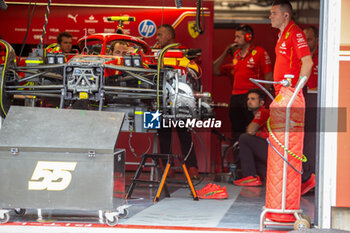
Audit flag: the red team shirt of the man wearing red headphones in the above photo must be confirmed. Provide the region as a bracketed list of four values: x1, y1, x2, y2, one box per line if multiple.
[232, 44, 272, 95]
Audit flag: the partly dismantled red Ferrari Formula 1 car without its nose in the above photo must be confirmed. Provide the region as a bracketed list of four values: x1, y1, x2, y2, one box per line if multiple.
[0, 33, 213, 132]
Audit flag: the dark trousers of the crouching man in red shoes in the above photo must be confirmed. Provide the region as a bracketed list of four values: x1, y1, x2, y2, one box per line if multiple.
[239, 133, 268, 177]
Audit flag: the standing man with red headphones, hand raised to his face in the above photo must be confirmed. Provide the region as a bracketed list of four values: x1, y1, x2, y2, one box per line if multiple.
[213, 25, 272, 141]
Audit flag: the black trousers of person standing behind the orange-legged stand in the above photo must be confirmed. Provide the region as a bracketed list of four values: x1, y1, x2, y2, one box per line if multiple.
[158, 127, 198, 168]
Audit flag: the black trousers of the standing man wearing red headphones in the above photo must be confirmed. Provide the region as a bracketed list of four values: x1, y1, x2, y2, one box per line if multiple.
[229, 94, 254, 142]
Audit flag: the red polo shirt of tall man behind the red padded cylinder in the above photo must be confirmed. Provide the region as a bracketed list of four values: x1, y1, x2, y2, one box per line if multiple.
[273, 20, 310, 93]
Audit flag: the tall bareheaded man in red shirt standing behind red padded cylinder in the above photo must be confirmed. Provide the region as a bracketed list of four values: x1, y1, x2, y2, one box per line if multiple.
[269, 0, 313, 94]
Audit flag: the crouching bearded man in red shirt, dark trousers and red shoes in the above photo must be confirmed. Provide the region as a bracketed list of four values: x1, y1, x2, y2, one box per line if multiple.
[233, 89, 270, 186]
